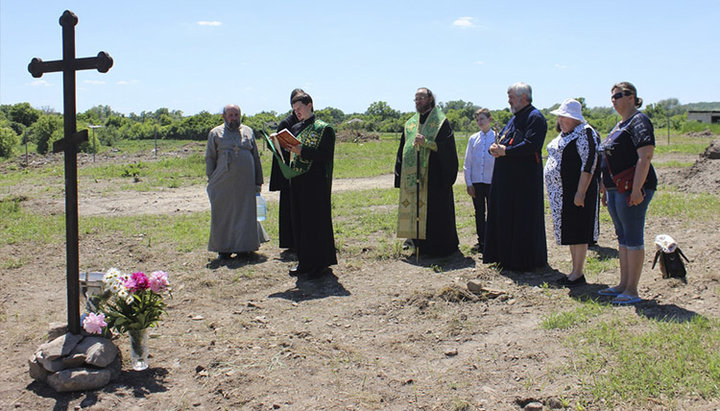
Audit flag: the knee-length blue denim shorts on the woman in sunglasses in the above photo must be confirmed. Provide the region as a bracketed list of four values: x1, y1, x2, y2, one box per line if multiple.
[607, 190, 655, 250]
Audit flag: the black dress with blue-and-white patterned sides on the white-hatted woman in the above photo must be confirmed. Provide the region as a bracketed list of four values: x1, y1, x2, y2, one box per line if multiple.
[544, 124, 600, 245]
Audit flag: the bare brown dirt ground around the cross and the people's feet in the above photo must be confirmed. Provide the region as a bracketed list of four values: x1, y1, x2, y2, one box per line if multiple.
[0, 140, 720, 410]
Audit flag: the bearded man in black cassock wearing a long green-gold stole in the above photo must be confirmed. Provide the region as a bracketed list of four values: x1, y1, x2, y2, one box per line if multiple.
[395, 88, 459, 257]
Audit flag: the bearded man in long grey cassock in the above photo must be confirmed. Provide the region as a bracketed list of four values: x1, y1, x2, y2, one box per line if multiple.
[205, 104, 269, 259]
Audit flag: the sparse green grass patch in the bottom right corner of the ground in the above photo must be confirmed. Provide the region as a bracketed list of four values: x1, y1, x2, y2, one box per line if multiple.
[572, 316, 720, 406]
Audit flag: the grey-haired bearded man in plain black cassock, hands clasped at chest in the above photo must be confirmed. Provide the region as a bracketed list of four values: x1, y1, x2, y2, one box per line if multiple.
[483, 83, 547, 271]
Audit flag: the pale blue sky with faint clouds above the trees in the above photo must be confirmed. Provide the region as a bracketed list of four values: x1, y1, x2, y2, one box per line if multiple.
[0, 0, 720, 115]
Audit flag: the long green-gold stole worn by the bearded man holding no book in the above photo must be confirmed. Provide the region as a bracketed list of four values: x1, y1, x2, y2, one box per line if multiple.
[397, 107, 445, 240]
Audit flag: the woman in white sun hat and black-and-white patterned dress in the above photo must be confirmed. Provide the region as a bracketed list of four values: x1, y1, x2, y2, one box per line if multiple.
[544, 99, 600, 287]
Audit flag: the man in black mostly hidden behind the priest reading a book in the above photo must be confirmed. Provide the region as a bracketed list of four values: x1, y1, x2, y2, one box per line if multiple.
[269, 88, 305, 251]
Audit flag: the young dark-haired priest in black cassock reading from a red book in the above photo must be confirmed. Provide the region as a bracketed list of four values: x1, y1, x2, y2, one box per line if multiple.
[289, 93, 337, 278]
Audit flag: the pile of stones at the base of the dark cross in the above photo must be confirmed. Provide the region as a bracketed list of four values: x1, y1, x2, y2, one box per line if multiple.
[28, 327, 122, 392]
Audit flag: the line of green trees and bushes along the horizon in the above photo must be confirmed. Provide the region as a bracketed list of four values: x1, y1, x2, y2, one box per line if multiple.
[0, 97, 720, 158]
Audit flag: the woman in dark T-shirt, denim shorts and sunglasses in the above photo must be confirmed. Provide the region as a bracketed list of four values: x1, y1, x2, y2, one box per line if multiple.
[598, 82, 657, 305]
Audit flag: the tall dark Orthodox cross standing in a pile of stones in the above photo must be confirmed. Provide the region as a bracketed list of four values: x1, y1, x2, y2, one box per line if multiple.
[28, 10, 113, 334]
